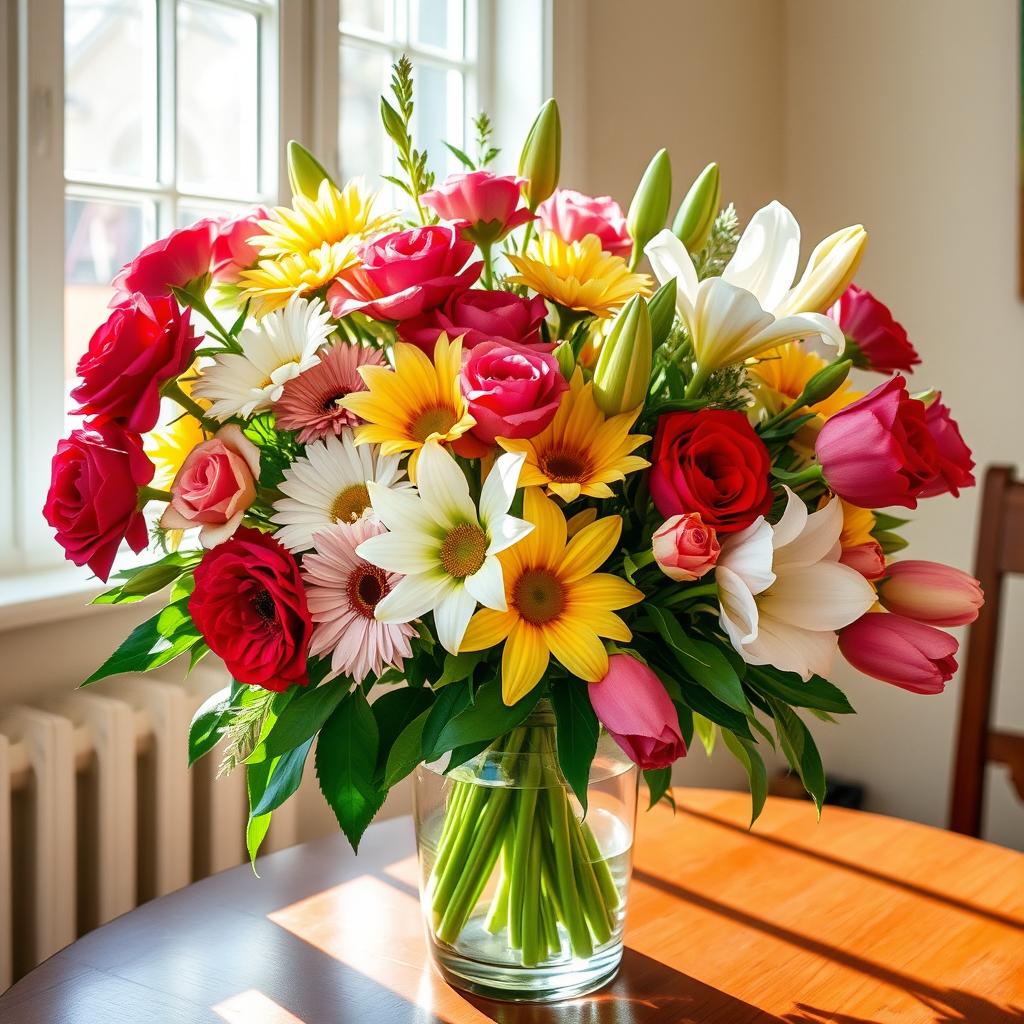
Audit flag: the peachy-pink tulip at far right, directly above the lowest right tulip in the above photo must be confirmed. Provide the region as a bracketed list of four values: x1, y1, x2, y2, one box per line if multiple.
[879, 559, 985, 626]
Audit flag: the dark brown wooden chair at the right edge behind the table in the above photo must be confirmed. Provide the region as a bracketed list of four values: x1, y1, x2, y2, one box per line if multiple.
[949, 466, 1024, 836]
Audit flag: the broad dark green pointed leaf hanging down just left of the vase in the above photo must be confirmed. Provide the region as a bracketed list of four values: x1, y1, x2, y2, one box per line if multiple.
[316, 689, 386, 852]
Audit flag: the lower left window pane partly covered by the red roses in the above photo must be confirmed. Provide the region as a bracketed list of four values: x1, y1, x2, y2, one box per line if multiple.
[65, 196, 156, 393]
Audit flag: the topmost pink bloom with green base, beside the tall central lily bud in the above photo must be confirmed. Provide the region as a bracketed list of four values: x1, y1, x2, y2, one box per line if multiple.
[423, 171, 535, 246]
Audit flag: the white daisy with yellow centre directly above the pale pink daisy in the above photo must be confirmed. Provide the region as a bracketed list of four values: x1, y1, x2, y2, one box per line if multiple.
[271, 427, 411, 551]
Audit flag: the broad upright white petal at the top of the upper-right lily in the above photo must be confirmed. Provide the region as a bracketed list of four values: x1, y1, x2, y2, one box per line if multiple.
[722, 200, 800, 310]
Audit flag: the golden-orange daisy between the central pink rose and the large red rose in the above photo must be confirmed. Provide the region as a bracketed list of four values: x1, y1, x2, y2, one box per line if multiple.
[498, 370, 650, 502]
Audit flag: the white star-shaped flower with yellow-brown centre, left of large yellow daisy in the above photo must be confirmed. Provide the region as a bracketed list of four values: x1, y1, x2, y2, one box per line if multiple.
[356, 441, 534, 654]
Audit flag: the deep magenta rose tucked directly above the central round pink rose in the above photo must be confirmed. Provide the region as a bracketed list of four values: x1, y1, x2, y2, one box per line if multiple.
[398, 288, 553, 355]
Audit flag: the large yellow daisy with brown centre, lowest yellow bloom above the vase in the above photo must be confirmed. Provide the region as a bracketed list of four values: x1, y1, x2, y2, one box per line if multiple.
[460, 487, 643, 705]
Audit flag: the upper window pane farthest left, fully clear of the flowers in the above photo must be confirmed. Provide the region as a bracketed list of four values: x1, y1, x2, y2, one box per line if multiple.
[65, 0, 157, 180]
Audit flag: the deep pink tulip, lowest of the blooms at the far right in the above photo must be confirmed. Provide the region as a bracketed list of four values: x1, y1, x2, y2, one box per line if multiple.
[839, 611, 959, 693]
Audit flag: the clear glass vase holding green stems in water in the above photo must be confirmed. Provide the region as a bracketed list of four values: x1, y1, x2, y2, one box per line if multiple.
[414, 701, 638, 1002]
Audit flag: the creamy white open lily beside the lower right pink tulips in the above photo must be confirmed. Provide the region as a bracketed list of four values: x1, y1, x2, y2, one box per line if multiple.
[715, 487, 876, 680]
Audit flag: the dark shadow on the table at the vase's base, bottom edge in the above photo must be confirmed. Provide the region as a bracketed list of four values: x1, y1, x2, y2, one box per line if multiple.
[465, 948, 779, 1024]
